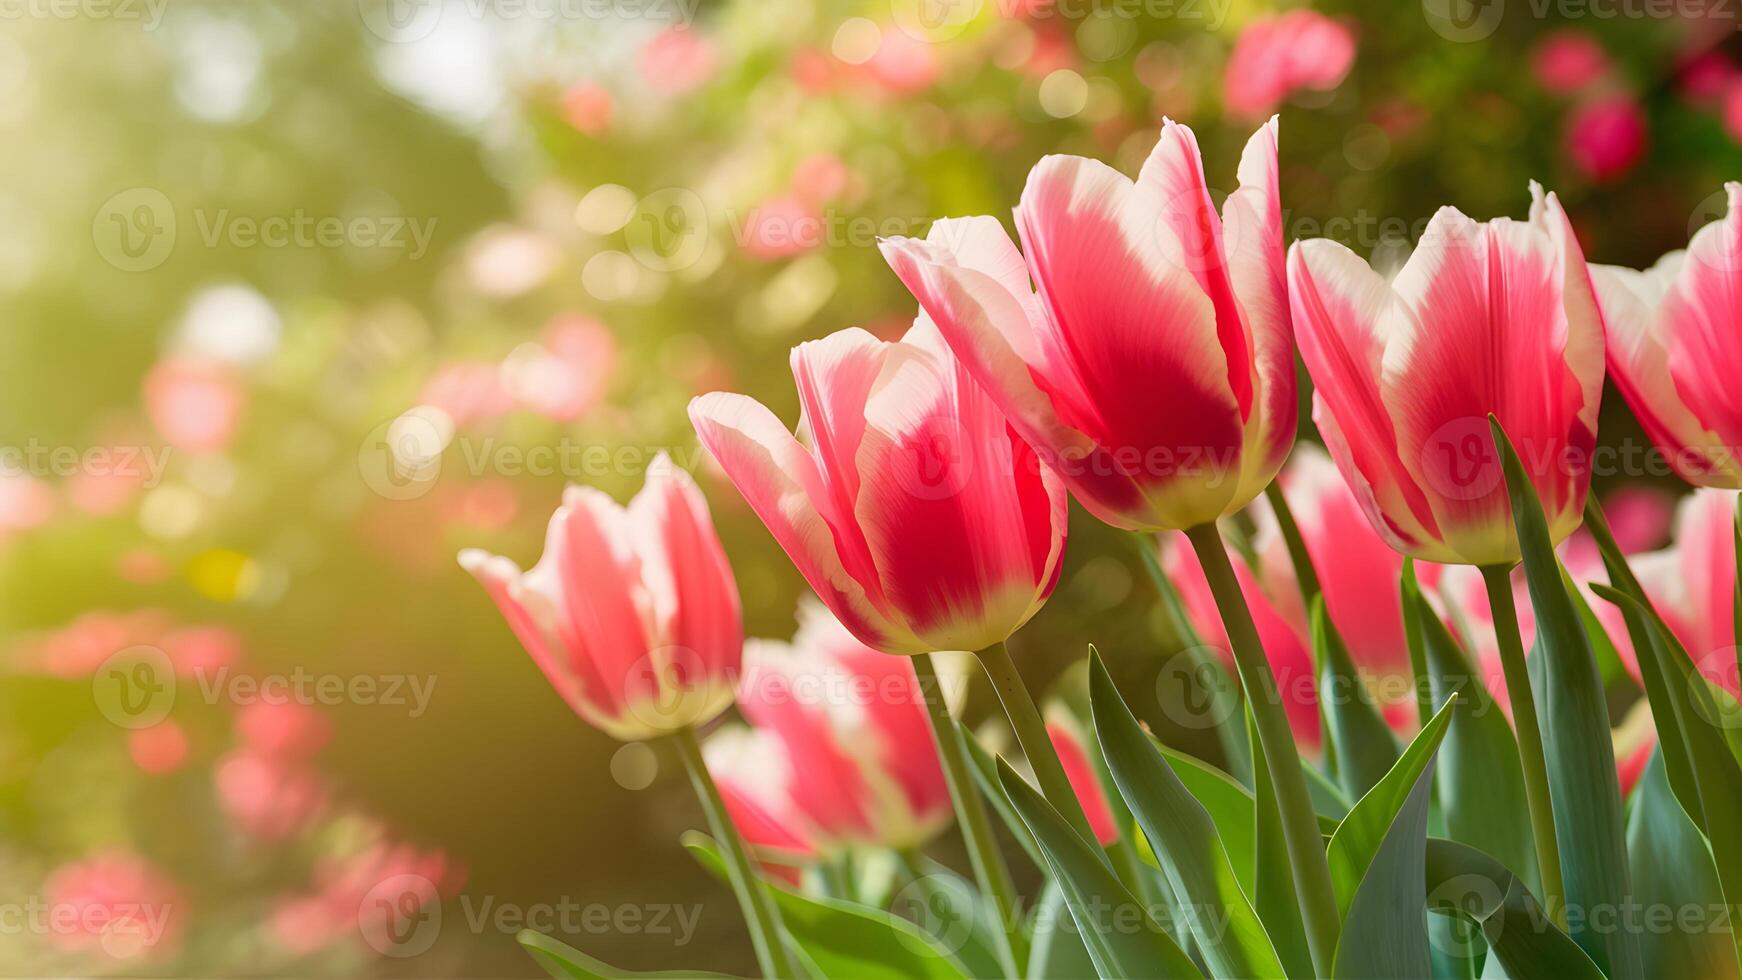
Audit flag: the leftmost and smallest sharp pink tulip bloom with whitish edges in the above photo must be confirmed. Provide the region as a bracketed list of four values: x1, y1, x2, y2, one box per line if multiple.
[460, 454, 744, 740]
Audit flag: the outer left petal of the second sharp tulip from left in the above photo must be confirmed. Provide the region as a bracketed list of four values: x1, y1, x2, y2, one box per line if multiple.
[690, 392, 913, 649]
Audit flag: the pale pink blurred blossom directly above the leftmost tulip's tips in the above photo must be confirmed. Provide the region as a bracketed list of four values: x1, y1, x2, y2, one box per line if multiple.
[502, 313, 617, 421]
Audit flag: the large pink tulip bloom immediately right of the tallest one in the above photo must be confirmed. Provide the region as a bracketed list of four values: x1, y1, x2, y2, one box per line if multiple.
[1289, 185, 1603, 564]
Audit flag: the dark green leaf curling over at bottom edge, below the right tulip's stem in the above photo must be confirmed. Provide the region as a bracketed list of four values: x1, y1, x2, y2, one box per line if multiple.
[1427, 837, 1595, 980]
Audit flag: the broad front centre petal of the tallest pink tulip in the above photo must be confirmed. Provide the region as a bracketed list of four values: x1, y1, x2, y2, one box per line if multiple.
[1017, 157, 1242, 527]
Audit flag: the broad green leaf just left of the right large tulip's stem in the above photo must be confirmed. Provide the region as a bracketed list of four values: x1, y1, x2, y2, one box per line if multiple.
[1409, 594, 1536, 888]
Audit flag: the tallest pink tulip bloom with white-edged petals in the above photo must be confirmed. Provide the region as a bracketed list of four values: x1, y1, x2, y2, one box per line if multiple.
[883, 120, 1294, 529]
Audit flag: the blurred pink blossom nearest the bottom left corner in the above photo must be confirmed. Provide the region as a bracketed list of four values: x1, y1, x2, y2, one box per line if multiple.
[42, 849, 186, 959]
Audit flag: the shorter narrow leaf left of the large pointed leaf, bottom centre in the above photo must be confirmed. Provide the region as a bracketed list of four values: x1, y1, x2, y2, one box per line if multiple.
[998, 759, 1202, 978]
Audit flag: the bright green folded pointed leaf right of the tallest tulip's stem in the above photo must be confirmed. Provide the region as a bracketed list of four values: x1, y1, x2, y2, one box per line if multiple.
[1326, 698, 1456, 980]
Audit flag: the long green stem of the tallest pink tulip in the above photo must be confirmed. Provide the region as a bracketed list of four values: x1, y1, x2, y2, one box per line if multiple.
[1186, 522, 1341, 977]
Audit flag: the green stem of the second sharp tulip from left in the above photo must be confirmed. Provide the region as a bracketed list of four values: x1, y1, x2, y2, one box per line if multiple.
[902, 653, 1028, 977]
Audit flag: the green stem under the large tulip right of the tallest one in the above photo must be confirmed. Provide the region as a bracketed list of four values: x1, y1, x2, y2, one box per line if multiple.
[1481, 564, 1566, 928]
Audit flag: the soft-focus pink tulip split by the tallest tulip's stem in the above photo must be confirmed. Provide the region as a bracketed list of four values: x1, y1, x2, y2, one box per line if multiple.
[1162, 534, 1319, 752]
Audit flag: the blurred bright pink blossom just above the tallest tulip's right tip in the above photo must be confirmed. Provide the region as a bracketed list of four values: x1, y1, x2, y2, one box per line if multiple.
[1223, 10, 1355, 118]
